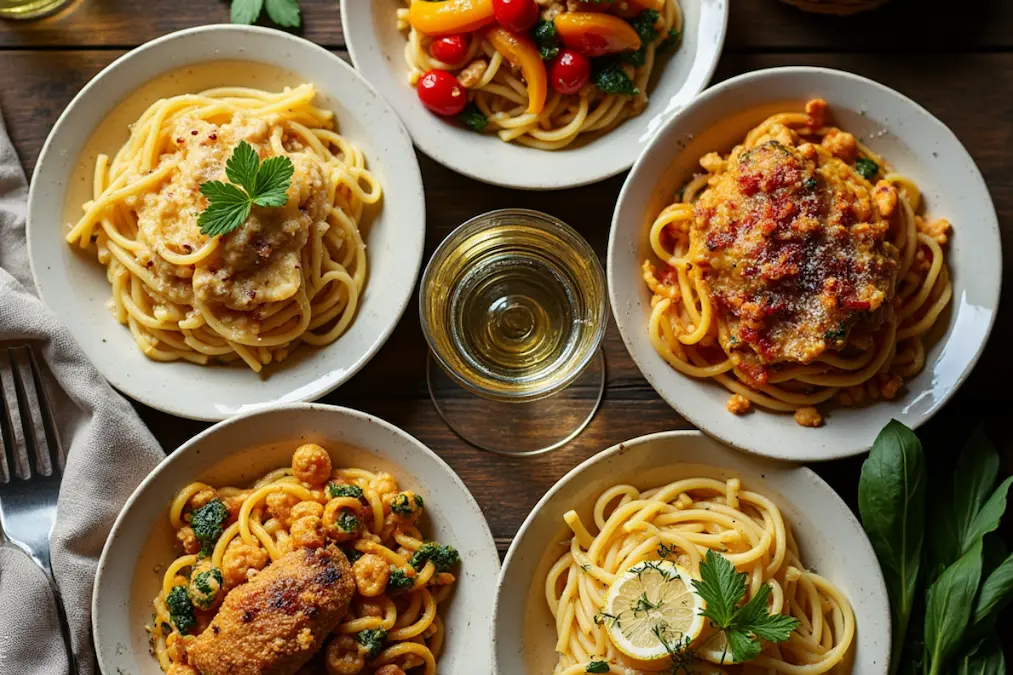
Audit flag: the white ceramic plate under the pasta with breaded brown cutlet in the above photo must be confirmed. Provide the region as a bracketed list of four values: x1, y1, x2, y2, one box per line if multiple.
[92, 403, 499, 675]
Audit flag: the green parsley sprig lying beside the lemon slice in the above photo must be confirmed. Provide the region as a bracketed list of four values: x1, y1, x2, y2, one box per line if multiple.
[693, 550, 799, 663]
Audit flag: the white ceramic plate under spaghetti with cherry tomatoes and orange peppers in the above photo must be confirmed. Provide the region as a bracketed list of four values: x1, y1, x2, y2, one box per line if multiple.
[341, 0, 728, 190]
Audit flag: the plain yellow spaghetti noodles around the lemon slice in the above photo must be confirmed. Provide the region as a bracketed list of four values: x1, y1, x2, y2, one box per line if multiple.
[545, 477, 855, 675]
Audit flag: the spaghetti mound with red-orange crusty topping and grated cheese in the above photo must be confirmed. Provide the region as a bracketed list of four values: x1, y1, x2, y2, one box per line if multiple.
[643, 99, 952, 426]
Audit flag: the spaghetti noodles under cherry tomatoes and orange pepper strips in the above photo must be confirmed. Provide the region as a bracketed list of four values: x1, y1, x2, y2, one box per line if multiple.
[397, 0, 683, 150]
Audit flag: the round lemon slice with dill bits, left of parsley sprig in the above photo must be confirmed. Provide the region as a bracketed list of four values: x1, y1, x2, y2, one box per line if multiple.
[602, 560, 704, 667]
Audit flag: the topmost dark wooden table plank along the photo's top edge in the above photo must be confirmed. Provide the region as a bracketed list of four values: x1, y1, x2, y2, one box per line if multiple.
[0, 0, 1013, 52]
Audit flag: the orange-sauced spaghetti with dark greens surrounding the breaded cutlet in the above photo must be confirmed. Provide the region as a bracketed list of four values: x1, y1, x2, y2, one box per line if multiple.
[147, 444, 459, 675]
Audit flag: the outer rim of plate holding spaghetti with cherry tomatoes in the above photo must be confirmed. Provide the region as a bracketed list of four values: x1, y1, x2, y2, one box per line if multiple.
[339, 0, 731, 192]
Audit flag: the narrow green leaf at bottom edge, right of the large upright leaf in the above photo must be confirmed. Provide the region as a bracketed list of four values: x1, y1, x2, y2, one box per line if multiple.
[925, 539, 982, 675]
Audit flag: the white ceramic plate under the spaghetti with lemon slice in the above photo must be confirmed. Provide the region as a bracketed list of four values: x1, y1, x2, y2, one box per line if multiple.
[492, 431, 890, 675]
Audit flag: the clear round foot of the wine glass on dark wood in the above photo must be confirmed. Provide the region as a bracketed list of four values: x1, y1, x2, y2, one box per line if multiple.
[425, 349, 605, 456]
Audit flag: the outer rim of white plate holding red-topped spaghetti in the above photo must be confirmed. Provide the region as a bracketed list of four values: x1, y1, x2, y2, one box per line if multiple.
[606, 66, 1003, 462]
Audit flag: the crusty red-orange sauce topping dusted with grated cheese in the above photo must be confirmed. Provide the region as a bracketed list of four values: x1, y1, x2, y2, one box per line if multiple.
[689, 138, 899, 385]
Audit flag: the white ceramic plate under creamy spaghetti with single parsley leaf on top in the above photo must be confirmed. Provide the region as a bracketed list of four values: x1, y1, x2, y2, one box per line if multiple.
[28, 25, 425, 420]
